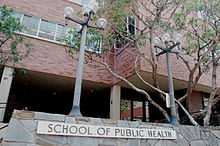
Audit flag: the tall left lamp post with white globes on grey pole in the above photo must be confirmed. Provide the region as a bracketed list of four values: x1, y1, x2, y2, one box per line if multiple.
[64, 3, 107, 117]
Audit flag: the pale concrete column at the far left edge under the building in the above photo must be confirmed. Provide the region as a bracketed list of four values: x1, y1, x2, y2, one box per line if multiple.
[0, 67, 14, 122]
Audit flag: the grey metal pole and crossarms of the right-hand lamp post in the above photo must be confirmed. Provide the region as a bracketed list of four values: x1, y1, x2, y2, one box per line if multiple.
[155, 42, 180, 124]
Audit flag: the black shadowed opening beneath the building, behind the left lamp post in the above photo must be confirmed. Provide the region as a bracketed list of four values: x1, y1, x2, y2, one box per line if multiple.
[4, 70, 110, 122]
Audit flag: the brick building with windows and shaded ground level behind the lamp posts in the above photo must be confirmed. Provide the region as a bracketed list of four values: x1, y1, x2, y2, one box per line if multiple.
[0, 0, 219, 124]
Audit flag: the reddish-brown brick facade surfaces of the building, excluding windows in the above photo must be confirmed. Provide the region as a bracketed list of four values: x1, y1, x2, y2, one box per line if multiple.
[0, 0, 217, 89]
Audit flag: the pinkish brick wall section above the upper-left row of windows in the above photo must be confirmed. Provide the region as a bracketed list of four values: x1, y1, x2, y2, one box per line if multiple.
[0, 0, 80, 23]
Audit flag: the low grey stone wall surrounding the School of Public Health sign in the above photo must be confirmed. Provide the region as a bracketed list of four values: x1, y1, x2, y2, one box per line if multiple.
[2, 111, 220, 146]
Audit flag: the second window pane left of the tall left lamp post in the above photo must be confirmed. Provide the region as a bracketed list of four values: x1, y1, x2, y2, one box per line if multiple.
[38, 19, 56, 40]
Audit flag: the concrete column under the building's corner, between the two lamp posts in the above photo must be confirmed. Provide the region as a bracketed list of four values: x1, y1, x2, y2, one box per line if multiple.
[110, 85, 121, 120]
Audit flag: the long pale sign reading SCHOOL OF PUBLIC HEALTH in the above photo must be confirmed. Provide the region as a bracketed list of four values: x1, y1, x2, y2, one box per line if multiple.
[37, 121, 176, 139]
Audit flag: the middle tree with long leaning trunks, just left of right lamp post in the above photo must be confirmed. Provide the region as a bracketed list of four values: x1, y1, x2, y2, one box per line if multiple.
[96, 0, 197, 125]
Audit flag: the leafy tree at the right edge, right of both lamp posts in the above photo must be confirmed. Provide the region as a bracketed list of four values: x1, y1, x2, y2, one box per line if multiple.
[172, 0, 220, 126]
